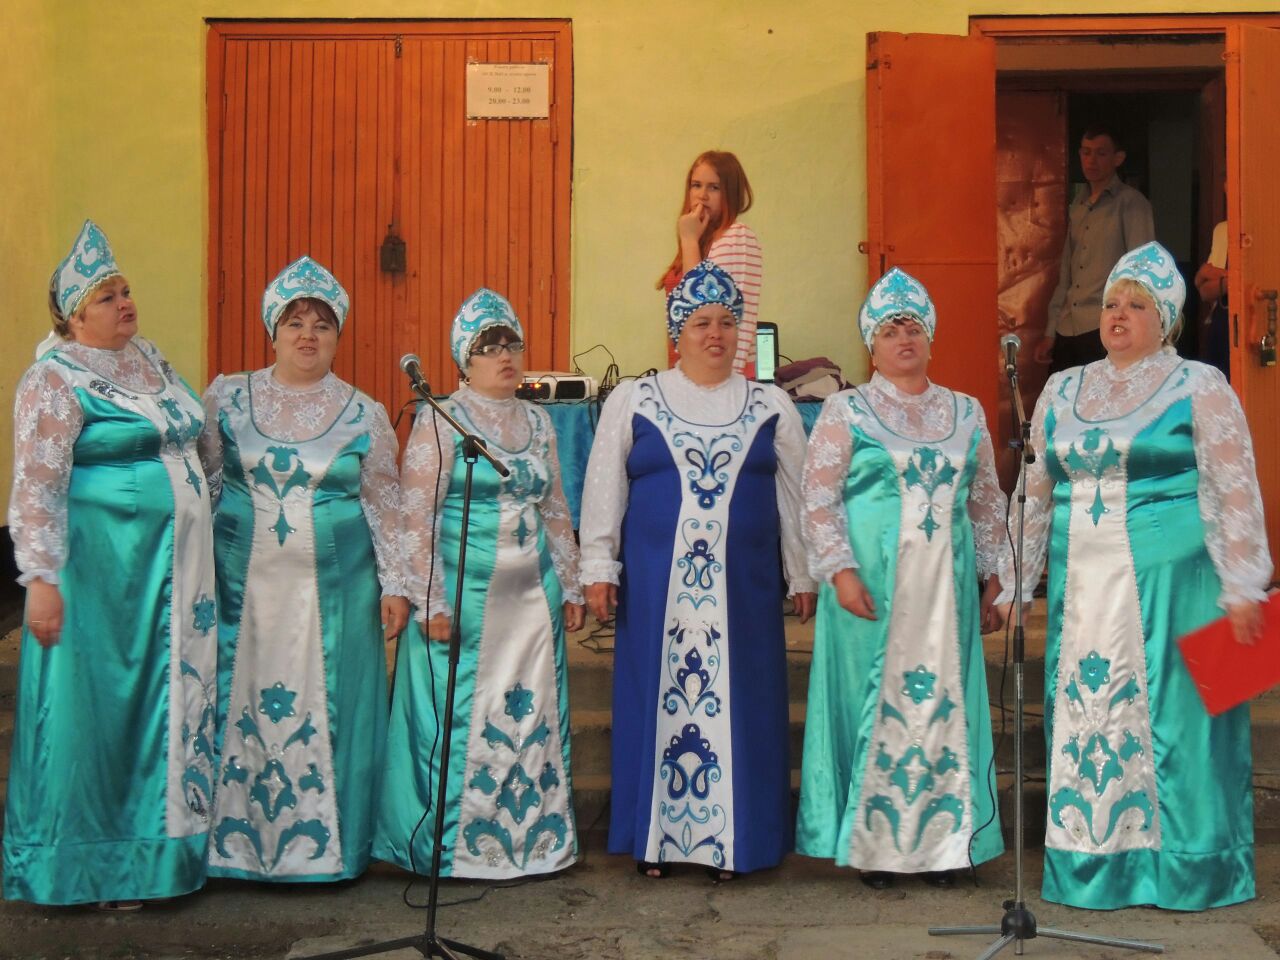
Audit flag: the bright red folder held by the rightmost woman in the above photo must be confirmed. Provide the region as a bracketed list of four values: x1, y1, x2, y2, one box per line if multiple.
[1178, 594, 1280, 717]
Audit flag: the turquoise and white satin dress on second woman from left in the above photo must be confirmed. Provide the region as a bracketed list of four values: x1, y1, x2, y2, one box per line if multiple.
[209, 374, 387, 882]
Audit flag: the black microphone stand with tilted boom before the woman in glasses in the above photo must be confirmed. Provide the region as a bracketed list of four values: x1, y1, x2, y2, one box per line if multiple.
[303, 374, 511, 960]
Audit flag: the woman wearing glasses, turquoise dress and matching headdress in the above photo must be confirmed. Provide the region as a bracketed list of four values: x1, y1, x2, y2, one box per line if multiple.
[374, 288, 585, 879]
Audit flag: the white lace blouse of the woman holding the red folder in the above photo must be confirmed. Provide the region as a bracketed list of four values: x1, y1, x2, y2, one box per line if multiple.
[1023, 348, 1271, 607]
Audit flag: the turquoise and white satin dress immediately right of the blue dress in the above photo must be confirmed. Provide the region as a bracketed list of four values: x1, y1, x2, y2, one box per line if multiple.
[796, 389, 1004, 873]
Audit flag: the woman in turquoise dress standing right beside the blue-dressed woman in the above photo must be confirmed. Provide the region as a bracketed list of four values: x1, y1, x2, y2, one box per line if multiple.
[796, 269, 1012, 890]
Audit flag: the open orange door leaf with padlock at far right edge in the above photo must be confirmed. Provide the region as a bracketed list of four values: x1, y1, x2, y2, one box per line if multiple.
[1226, 24, 1280, 570]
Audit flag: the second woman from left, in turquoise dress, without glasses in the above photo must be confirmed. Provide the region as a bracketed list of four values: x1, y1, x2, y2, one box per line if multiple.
[200, 256, 408, 882]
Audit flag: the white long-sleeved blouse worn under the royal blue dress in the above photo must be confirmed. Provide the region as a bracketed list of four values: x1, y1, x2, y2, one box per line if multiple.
[580, 366, 817, 596]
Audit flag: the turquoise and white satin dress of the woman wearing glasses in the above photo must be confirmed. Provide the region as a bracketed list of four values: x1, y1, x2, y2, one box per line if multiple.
[374, 399, 577, 879]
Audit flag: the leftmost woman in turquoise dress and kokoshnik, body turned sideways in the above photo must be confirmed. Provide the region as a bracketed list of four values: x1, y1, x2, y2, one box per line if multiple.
[4, 220, 216, 909]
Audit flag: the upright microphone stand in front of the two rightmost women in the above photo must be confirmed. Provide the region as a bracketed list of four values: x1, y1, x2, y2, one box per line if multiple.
[929, 361, 1165, 960]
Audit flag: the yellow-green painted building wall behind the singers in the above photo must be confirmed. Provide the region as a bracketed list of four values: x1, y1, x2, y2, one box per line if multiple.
[0, 0, 1272, 522]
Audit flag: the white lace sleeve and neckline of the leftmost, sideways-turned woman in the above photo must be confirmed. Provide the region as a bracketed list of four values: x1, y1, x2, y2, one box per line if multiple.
[9, 337, 186, 584]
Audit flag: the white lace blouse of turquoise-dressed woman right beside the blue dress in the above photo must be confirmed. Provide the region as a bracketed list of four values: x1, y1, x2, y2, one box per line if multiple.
[804, 374, 1012, 584]
